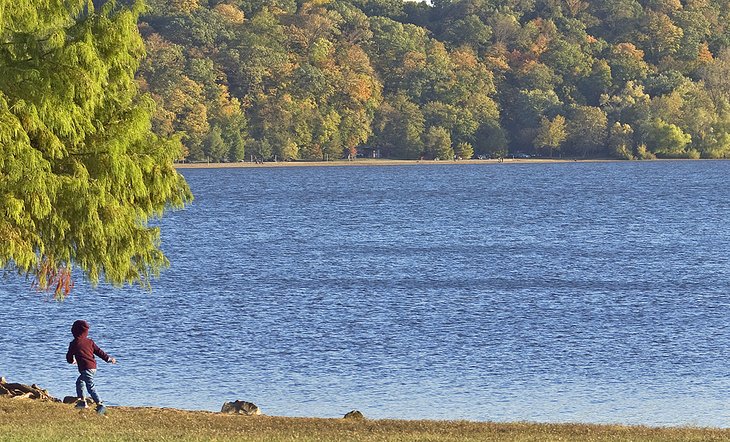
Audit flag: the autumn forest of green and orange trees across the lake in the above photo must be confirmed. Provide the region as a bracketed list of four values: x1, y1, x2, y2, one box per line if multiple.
[137, 0, 730, 161]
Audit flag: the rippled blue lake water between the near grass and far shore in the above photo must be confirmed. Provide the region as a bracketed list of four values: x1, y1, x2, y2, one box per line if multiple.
[0, 161, 730, 427]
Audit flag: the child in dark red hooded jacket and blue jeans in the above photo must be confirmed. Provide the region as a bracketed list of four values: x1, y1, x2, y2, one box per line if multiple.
[66, 320, 117, 414]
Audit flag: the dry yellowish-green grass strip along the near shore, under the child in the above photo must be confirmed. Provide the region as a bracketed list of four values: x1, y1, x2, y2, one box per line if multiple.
[0, 398, 730, 442]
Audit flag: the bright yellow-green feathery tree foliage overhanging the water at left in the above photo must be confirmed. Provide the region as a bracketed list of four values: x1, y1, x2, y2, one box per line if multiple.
[0, 0, 191, 297]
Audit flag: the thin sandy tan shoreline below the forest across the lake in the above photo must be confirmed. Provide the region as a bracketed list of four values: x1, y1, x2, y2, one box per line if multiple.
[175, 158, 620, 169]
